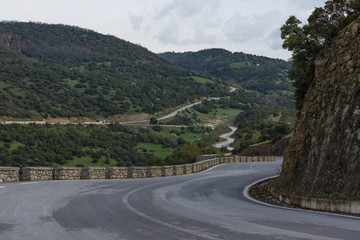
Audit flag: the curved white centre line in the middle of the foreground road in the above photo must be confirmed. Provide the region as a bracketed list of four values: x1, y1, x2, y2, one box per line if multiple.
[123, 184, 221, 240]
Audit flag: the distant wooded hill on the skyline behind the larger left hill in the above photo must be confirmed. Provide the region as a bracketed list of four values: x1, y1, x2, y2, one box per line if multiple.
[160, 49, 293, 93]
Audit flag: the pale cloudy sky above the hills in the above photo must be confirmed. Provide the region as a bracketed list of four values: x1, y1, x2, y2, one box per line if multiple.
[0, 0, 326, 59]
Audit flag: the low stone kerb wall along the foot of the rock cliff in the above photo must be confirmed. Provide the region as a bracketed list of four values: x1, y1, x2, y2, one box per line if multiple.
[269, 187, 360, 214]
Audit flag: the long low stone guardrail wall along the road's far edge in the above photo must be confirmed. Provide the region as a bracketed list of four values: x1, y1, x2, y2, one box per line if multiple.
[0, 156, 276, 182]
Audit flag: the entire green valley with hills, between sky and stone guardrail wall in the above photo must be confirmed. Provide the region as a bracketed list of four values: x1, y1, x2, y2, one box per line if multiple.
[0, 22, 295, 169]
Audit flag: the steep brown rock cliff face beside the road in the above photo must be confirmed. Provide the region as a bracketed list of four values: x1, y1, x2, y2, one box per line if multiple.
[280, 18, 360, 198]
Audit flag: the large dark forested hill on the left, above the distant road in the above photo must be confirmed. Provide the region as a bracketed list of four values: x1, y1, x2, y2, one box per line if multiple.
[0, 22, 226, 119]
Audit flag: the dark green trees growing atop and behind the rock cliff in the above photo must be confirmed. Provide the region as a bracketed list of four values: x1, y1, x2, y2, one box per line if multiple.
[281, 0, 360, 110]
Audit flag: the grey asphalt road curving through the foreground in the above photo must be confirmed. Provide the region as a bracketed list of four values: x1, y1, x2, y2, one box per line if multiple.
[0, 161, 360, 240]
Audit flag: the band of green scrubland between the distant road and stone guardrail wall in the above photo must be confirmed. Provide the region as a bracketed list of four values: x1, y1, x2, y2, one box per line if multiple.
[0, 124, 217, 167]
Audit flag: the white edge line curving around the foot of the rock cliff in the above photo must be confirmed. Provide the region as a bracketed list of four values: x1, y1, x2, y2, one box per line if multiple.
[243, 175, 360, 220]
